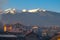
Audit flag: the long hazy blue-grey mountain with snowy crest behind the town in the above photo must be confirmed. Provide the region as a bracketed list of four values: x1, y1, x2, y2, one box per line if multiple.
[0, 9, 60, 26]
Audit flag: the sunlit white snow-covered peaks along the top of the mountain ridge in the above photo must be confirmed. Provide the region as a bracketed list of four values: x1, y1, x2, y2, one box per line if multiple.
[4, 8, 46, 14]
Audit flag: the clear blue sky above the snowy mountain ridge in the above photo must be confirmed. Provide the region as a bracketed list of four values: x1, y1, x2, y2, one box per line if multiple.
[2, 0, 60, 12]
